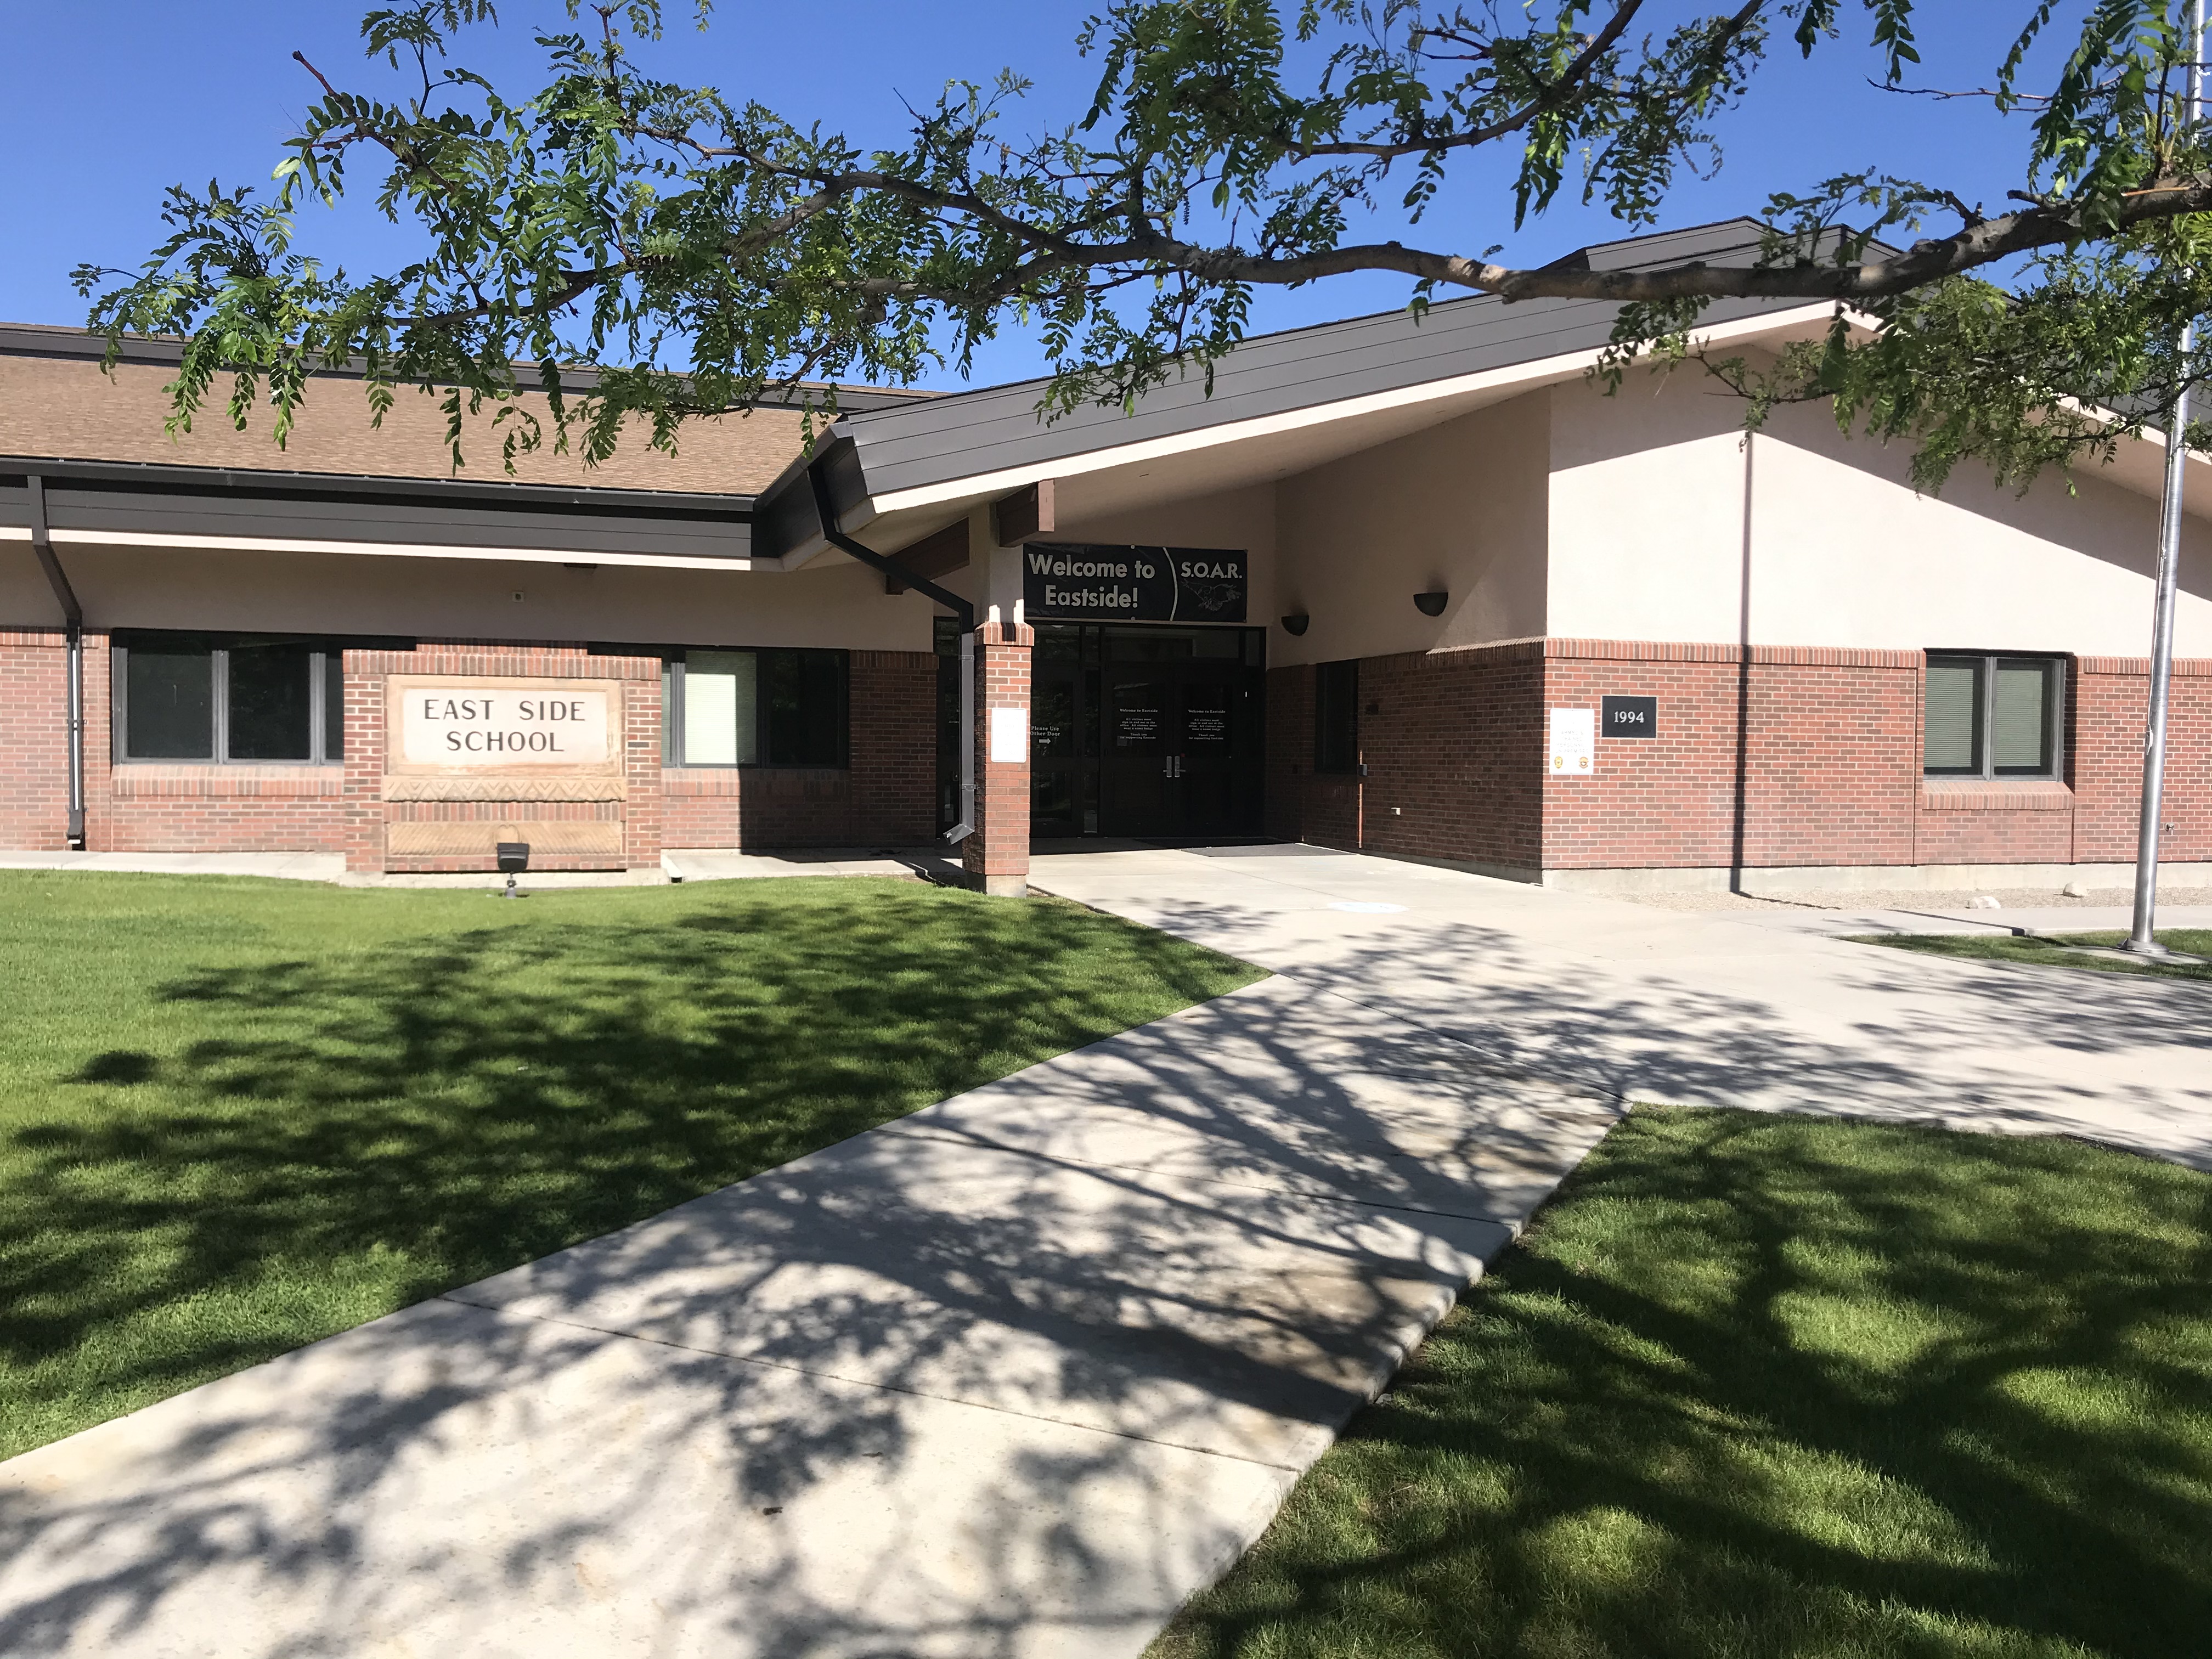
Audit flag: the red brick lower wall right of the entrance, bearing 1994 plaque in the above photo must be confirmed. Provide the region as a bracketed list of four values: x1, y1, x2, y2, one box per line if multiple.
[1267, 639, 2212, 874]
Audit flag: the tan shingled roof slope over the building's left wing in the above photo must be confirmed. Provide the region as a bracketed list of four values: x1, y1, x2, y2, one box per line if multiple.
[0, 356, 832, 495]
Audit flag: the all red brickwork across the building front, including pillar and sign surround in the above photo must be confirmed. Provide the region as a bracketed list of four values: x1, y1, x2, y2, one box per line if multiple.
[0, 626, 2212, 885]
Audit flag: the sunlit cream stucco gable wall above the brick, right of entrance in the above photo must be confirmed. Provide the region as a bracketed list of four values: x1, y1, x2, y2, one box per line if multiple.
[1546, 374, 2212, 657]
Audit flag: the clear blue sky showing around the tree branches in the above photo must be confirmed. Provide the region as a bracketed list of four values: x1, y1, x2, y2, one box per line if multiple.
[0, 0, 2075, 387]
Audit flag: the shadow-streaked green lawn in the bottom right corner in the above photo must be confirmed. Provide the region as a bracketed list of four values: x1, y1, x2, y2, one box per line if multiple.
[1153, 1108, 2212, 1659]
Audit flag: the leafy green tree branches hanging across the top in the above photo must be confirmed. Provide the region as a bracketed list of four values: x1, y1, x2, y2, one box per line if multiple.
[64, 0, 2212, 487]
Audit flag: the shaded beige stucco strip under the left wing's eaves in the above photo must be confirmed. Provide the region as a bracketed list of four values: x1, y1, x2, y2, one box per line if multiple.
[0, 542, 934, 650]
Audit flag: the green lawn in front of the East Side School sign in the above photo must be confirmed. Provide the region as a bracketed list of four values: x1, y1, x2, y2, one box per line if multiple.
[0, 872, 1259, 1458]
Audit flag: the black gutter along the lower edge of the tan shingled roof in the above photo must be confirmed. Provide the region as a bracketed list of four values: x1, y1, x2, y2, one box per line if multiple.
[0, 456, 754, 522]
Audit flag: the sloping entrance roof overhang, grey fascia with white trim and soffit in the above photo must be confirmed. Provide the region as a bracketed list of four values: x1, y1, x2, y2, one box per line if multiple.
[752, 219, 2212, 568]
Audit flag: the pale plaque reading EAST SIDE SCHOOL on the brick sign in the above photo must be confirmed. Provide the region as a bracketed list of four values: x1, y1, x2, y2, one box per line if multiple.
[385, 675, 622, 772]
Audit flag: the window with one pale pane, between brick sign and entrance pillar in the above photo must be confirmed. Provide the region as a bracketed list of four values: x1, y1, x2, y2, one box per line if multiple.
[662, 650, 845, 765]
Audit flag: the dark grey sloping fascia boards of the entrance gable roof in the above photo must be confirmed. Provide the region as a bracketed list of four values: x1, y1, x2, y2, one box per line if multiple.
[814, 219, 1867, 504]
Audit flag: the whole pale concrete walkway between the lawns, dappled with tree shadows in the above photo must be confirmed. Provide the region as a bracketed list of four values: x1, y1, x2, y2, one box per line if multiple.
[0, 847, 2212, 1659]
